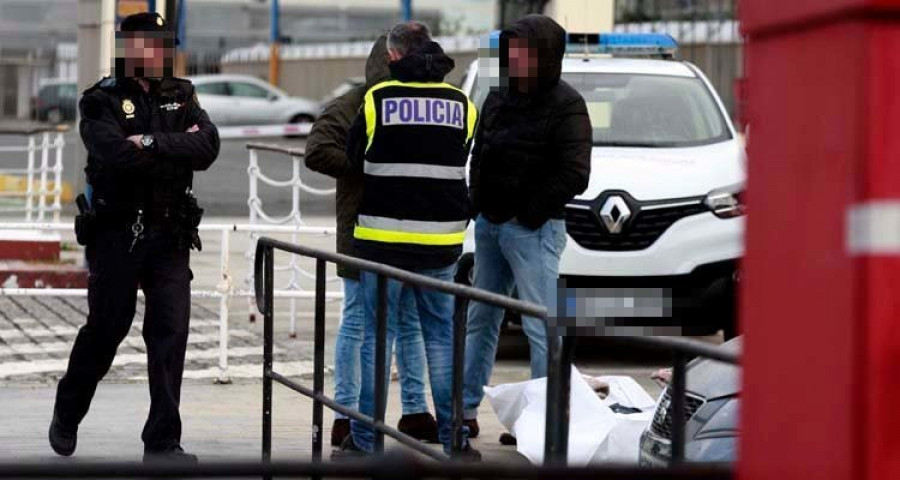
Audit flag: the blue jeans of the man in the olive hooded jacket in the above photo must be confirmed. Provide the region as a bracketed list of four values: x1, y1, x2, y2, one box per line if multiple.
[334, 278, 428, 418]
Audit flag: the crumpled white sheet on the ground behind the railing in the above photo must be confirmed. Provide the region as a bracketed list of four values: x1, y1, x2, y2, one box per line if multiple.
[484, 367, 655, 465]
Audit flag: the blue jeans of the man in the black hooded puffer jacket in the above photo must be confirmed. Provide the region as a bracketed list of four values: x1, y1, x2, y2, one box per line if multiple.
[464, 216, 566, 419]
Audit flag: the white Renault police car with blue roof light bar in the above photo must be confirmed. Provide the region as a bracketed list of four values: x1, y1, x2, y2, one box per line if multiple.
[458, 34, 746, 336]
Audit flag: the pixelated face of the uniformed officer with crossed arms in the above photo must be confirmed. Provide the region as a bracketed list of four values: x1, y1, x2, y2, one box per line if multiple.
[115, 32, 175, 78]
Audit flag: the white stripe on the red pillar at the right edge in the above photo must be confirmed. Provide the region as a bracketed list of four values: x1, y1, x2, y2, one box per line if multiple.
[846, 200, 900, 255]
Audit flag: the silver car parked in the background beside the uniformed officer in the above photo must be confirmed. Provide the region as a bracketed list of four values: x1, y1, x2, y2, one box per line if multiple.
[190, 75, 319, 125]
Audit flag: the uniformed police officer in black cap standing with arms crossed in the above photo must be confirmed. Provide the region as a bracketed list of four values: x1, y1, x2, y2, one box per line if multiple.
[49, 13, 219, 462]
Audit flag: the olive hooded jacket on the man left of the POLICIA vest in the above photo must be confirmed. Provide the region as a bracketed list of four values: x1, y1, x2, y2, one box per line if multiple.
[305, 36, 390, 279]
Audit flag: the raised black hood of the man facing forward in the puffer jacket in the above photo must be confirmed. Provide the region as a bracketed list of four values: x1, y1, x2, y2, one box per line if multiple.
[500, 14, 566, 90]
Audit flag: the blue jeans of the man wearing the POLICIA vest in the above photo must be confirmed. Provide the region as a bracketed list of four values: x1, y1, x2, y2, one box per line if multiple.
[350, 264, 464, 452]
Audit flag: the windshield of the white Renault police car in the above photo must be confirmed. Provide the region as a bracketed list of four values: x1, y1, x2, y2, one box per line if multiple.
[562, 73, 731, 147]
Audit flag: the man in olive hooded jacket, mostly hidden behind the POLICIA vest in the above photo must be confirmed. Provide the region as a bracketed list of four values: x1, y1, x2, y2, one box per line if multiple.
[305, 35, 437, 447]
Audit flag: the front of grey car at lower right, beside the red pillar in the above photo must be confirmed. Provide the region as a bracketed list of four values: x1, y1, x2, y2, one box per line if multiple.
[640, 337, 742, 467]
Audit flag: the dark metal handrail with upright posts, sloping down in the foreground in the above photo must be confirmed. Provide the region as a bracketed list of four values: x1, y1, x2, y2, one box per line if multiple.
[254, 238, 738, 472]
